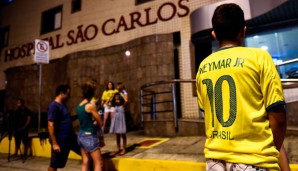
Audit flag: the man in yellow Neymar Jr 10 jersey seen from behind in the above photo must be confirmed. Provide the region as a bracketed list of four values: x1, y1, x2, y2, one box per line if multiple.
[196, 4, 286, 171]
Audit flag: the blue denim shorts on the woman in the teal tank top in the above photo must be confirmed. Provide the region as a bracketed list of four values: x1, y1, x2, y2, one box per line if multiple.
[78, 131, 100, 153]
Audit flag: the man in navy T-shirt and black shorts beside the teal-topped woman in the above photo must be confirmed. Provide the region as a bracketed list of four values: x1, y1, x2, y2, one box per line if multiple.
[48, 85, 81, 171]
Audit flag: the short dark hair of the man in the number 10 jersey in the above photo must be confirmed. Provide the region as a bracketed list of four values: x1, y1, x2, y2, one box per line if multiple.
[212, 3, 245, 41]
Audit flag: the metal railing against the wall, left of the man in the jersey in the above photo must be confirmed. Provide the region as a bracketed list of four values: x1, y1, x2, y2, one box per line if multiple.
[140, 79, 196, 129]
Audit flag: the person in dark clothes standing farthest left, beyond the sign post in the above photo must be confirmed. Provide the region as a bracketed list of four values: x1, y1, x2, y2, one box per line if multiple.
[13, 99, 31, 157]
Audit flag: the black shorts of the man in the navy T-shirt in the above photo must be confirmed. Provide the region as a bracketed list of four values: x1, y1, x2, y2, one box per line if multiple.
[50, 134, 81, 169]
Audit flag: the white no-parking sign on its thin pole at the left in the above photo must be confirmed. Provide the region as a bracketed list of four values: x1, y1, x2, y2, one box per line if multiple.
[34, 39, 50, 133]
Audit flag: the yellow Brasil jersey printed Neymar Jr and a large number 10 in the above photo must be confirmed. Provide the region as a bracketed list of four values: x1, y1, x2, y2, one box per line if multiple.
[196, 47, 284, 170]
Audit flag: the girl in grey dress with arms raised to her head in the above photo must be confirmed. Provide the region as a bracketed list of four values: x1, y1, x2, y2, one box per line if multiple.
[110, 93, 127, 155]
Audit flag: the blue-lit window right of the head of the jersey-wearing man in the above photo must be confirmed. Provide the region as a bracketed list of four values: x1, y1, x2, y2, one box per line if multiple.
[245, 26, 298, 78]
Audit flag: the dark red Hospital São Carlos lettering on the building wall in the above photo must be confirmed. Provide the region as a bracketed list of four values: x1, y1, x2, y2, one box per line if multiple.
[4, 0, 190, 62]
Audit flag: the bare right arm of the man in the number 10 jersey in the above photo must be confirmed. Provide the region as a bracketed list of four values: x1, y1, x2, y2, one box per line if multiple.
[268, 105, 287, 151]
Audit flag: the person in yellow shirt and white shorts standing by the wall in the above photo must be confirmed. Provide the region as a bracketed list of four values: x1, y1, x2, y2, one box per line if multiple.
[101, 81, 118, 130]
